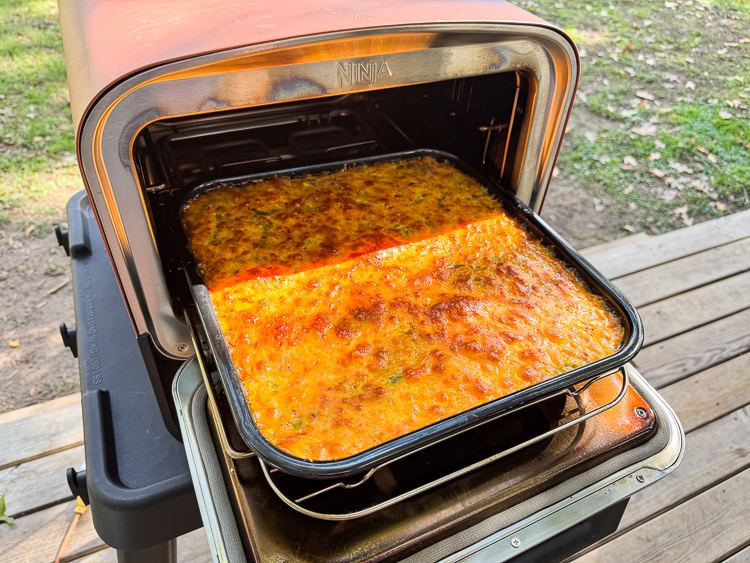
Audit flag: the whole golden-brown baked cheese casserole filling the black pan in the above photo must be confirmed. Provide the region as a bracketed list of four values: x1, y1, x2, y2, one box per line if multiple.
[186, 159, 624, 460]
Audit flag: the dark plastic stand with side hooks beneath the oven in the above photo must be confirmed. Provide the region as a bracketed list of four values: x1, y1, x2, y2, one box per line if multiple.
[57, 192, 676, 563]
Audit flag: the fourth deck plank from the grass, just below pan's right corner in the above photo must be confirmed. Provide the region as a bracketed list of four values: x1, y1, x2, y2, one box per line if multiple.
[633, 309, 750, 389]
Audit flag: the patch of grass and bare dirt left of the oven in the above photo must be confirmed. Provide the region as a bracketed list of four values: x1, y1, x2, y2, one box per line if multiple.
[0, 0, 82, 224]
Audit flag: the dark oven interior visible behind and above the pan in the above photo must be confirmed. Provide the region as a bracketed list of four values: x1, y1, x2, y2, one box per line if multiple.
[133, 72, 529, 324]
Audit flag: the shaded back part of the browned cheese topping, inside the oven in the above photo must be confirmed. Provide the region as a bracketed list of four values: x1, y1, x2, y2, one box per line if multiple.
[183, 158, 502, 289]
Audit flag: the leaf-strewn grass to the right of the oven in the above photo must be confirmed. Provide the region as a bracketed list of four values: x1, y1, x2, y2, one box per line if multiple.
[521, 0, 750, 233]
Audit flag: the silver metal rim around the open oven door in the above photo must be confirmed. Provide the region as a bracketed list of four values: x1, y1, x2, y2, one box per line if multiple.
[173, 359, 685, 563]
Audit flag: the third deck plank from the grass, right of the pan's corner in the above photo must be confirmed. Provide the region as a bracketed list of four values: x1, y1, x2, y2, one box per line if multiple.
[638, 272, 750, 346]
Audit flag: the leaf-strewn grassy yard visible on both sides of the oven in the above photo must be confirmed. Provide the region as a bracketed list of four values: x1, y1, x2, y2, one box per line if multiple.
[0, 0, 750, 238]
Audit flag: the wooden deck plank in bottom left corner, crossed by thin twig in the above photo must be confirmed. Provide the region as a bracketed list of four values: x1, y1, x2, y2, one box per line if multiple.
[0, 501, 106, 563]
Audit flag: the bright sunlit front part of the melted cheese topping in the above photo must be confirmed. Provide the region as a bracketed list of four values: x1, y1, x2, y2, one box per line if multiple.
[211, 215, 624, 460]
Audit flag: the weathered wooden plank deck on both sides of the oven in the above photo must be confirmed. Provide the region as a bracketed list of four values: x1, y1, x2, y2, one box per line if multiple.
[0, 211, 750, 563]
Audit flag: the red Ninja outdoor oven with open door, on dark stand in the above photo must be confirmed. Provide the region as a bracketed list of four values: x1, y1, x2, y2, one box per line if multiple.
[57, 0, 684, 562]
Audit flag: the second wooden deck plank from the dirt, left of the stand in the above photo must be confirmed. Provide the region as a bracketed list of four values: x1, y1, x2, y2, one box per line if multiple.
[0, 446, 84, 518]
